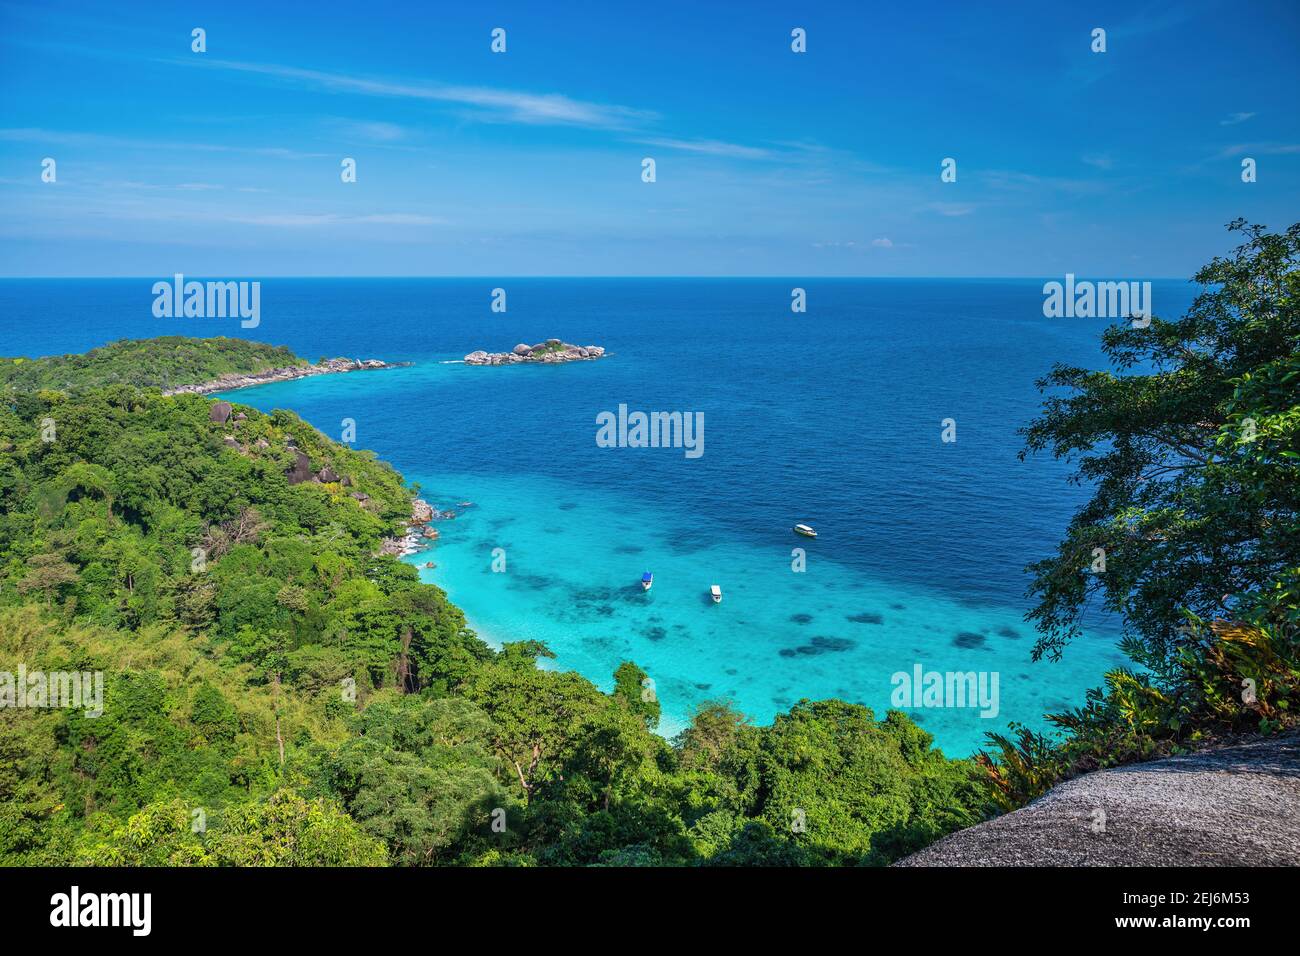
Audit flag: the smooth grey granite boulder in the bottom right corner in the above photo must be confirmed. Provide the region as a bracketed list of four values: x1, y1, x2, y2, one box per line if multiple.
[896, 735, 1300, 866]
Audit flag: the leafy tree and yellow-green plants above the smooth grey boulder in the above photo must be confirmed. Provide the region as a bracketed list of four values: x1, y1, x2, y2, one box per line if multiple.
[979, 220, 1300, 809]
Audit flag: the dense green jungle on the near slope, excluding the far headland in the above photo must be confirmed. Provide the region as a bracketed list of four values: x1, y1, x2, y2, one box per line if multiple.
[0, 374, 985, 866]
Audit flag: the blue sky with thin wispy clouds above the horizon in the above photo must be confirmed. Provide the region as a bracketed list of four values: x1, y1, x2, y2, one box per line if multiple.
[0, 0, 1300, 278]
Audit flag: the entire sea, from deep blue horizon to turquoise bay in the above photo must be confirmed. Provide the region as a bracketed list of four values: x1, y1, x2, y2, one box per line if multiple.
[0, 278, 1195, 754]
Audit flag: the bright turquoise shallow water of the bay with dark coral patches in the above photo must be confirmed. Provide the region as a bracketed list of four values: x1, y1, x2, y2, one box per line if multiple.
[411, 475, 1119, 753]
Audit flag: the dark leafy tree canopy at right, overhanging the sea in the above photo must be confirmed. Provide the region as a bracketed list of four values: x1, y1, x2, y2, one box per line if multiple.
[1024, 220, 1300, 665]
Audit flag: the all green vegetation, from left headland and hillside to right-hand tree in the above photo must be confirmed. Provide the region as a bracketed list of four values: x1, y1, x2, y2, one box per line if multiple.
[0, 222, 1300, 866]
